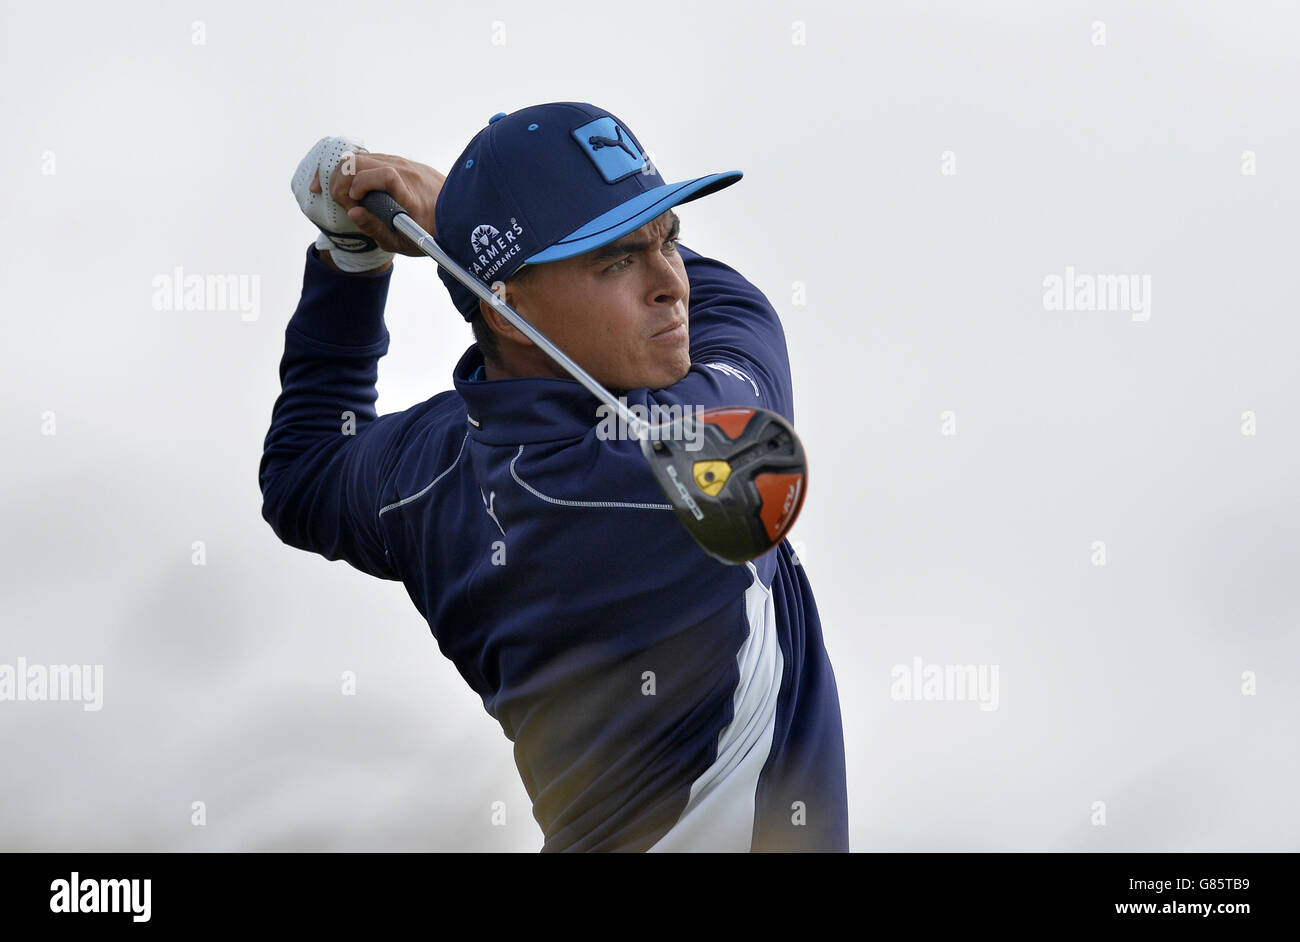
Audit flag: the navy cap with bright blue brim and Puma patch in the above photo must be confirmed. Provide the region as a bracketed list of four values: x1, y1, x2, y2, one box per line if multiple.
[433, 101, 742, 321]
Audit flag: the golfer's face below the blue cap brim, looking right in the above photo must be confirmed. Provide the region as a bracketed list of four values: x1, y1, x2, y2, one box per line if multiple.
[521, 209, 690, 390]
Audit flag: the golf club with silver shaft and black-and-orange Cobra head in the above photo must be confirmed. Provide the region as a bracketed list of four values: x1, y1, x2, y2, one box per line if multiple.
[361, 190, 807, 565]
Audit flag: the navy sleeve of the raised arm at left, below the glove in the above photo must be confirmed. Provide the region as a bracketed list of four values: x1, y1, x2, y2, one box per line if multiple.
[259, 246, 406, 579]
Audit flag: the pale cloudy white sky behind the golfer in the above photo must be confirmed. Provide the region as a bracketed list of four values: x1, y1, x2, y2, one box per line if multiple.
[0, 0, 1300, 851]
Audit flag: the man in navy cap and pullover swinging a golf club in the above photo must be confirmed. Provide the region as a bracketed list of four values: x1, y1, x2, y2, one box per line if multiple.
[260, 101, 848, 851]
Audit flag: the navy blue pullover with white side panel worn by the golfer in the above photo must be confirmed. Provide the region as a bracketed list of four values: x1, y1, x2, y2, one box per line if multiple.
[259, 239, 849, 852]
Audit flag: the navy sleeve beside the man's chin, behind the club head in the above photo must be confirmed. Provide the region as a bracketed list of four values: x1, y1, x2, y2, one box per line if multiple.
[651, 246, 794, 422]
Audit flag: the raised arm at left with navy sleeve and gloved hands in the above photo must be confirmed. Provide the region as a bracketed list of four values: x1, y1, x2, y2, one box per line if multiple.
[257, 138, 442, 579]
